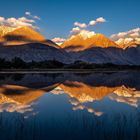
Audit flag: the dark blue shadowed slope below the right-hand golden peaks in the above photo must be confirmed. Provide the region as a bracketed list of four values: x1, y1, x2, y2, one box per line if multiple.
[71, 46, 140, 65]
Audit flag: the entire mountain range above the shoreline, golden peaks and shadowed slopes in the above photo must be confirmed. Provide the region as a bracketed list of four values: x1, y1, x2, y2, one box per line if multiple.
[0, 26, 140, 65]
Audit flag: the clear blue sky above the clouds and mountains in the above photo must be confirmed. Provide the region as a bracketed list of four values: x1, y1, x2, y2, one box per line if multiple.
[0, 0, 140, 38]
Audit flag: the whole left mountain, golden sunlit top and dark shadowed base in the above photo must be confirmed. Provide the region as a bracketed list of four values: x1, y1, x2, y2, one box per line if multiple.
[0, 27, 71, 63]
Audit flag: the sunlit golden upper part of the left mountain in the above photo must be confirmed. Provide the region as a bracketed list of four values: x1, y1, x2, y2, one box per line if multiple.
[0, 26, 58, 48]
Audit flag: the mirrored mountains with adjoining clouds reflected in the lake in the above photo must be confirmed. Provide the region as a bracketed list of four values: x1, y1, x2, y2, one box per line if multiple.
[0, 72, 140, 116]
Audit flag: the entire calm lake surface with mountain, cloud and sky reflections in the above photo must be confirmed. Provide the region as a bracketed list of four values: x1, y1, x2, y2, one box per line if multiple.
[0, 72, 140, 140]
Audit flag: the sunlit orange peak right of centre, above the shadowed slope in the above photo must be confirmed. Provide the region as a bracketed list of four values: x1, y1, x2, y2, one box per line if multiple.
[61, 34, 120, 52]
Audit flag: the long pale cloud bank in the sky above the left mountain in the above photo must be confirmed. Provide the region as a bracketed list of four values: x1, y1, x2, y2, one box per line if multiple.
[0, 17, 38, 29]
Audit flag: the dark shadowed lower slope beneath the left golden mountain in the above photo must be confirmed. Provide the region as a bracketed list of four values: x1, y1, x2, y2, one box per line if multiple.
[0, 43, 72, 64]
